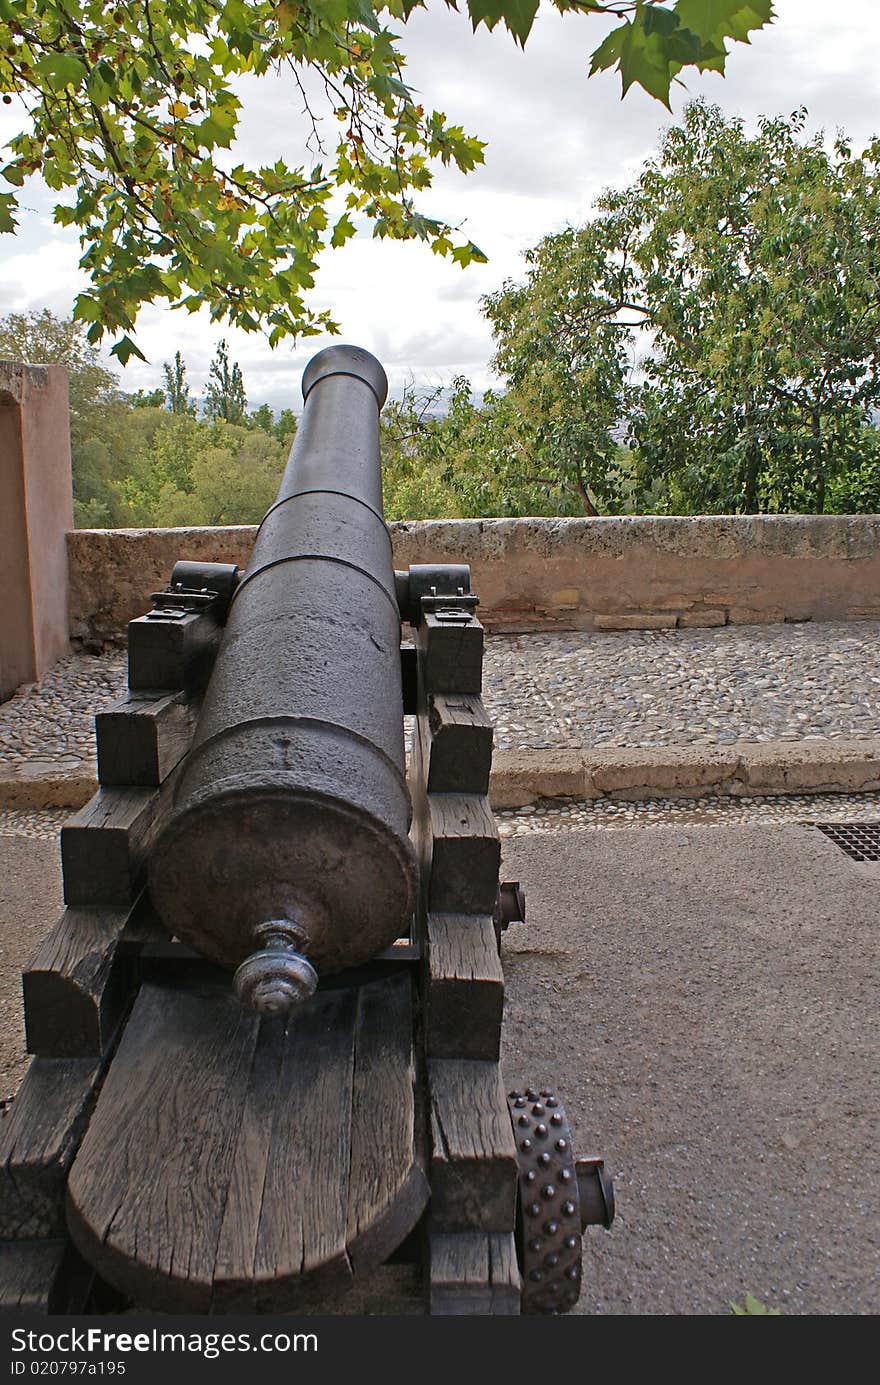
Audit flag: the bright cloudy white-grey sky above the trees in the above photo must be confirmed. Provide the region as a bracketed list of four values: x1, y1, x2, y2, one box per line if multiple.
[0, 0, 880, 410]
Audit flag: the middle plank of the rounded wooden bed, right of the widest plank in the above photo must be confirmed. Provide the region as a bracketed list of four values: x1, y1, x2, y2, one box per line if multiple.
[255, 989, 358, 1313]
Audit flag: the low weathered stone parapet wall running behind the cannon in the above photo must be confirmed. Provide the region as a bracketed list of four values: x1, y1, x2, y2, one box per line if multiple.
[68, 515, 880, 643]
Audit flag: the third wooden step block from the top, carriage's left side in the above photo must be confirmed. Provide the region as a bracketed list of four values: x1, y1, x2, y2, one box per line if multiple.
[61, 771, 176, 907]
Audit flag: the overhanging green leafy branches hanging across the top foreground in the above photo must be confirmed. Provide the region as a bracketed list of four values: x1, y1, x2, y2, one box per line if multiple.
[0, 0, 772, 364]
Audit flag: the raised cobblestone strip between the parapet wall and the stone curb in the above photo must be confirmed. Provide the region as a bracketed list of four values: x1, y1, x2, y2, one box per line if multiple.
[0, 620, 880, 774]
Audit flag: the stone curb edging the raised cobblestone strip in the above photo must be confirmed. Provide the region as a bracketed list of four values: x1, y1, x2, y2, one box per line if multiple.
[0, 738, 880, 812]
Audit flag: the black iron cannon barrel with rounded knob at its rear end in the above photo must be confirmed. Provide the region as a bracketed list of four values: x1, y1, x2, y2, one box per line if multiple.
[150, 346, 416, 1014]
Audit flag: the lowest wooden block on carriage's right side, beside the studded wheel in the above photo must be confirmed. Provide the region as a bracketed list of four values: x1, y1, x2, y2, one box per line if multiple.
[430, 1231, 521, 1317]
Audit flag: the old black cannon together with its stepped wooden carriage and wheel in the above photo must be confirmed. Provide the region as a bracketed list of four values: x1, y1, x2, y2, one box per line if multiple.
[0, 346, 614, 1314]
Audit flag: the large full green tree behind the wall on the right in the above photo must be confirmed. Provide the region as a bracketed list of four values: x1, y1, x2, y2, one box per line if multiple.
[485, 102, 880, 512]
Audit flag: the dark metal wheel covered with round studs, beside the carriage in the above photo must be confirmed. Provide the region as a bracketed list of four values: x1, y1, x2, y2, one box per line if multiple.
[507, 1087, 581, 1313]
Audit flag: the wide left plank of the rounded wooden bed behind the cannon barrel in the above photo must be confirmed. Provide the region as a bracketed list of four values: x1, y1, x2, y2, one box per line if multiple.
[68, 986, 259, 1313]
